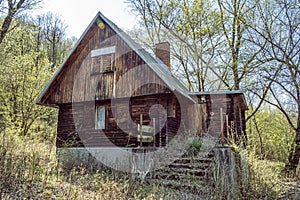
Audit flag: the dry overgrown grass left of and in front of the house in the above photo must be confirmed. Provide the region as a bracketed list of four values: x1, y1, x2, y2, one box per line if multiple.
[0, 132, 158, 199]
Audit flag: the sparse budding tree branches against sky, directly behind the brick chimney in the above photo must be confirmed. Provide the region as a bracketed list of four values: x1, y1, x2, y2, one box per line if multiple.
[127, 0, 228, 91]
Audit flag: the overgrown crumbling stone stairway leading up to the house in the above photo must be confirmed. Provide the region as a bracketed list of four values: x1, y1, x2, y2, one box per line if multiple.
[146, 151, 214, 195]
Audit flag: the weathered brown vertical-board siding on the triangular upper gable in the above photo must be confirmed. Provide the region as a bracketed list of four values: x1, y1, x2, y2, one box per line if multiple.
[41, 18, 167, 105]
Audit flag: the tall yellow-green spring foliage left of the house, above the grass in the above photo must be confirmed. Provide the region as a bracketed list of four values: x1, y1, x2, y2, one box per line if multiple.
[0, 17, 56, 139]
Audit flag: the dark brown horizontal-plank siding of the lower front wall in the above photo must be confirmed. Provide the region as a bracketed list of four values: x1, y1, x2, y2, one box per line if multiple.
[57, 94, 182, 147]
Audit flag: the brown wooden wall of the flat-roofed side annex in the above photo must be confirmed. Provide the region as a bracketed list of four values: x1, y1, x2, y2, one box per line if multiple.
[198, 94, 246, 141]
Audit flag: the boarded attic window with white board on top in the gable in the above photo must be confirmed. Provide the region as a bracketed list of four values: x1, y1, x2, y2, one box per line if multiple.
[91, 46, 116, 75]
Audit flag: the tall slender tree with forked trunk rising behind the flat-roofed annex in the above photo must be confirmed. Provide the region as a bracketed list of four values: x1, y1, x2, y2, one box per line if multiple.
[218, 0, 265, 90]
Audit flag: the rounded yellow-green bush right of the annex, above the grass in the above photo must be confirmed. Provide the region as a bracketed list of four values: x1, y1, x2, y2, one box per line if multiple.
[247, 109, 296, 162]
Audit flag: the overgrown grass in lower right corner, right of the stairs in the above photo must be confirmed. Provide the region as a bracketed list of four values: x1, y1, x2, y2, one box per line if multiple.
[241, 152, 300, 199]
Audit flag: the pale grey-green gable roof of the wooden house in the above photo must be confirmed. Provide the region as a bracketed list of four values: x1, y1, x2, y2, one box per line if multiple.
[35, 12, 195, 104]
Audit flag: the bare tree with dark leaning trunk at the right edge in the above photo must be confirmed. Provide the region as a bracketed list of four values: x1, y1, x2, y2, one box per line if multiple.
[251, 0, 300, 173]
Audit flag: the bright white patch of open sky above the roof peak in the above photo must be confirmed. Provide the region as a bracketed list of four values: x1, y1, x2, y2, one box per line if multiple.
[37, 0, 137, 38]
